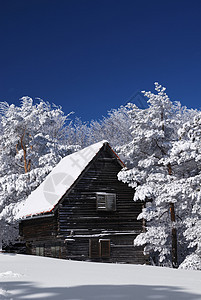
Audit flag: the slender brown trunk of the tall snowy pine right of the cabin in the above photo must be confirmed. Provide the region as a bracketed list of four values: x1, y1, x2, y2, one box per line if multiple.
[168, 164, 178, 268]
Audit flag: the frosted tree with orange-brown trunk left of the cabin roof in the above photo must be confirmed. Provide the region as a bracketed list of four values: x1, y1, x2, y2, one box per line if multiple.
[0, 97, 76, 247]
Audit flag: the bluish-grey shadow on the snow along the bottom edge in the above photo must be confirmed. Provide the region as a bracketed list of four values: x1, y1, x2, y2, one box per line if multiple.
[0, 281, 201, 300]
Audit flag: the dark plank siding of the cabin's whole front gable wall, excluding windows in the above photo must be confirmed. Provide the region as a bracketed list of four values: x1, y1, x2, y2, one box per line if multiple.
[58, 146, 145, 263]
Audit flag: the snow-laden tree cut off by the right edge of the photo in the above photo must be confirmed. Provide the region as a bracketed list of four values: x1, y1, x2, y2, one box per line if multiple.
[168, 112, 201, 270]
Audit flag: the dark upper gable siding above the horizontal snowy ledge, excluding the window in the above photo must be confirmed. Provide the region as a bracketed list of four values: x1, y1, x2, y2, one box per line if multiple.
[58, 151, 142, 235]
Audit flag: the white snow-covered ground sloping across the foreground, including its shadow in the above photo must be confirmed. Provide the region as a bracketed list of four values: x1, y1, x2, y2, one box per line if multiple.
[0, 253, 201, 300]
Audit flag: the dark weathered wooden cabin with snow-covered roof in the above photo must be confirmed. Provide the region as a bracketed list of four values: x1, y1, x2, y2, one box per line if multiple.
[18, 141, 146, 264]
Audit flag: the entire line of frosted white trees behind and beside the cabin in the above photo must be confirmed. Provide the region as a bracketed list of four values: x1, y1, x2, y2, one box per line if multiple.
[0, 83, 201, 269]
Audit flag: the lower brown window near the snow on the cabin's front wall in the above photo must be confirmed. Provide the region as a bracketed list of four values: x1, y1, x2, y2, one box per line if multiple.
[89, 239, 110, 258]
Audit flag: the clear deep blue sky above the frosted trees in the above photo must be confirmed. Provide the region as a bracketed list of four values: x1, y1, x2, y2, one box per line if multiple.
[0, 0, 201, 121]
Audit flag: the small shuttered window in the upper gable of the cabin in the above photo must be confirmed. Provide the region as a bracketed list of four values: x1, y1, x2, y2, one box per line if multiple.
[96, 193, 116, 211]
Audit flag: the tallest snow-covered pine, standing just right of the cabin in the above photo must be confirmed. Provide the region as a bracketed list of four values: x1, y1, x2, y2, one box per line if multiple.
[119, 83, 195, 267]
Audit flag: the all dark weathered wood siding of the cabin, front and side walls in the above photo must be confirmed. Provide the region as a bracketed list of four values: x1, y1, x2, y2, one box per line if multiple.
[21, 146, 145, 263]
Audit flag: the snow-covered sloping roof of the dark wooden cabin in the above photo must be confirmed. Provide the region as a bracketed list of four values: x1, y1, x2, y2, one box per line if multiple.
[16, 140, 108, 219]
